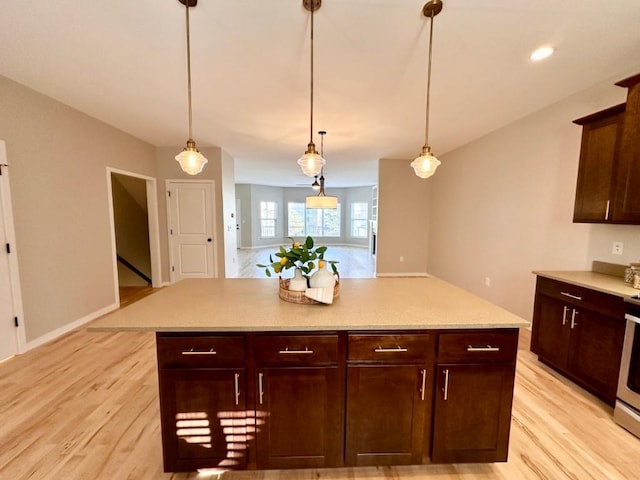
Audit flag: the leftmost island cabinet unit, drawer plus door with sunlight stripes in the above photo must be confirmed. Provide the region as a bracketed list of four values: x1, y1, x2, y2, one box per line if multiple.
[157, 336, 252, 472]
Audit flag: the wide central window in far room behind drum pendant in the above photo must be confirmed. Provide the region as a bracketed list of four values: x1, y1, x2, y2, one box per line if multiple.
[287, 203, 340, 237]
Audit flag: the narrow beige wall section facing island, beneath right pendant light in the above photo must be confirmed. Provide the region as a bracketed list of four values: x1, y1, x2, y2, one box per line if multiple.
[376, 159, 432, 276]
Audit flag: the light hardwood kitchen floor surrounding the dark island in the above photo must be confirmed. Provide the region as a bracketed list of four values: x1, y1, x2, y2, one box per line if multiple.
[0, 328, 640, 480]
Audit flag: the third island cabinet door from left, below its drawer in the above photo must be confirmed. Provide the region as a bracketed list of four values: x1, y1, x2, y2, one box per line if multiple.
[346, 365, 433, 466]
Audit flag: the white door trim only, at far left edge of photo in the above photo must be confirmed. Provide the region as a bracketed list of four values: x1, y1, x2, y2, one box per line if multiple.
[0, 140, 27, 353]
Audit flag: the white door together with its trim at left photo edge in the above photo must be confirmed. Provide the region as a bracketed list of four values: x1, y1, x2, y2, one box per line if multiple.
[0, 140, 26, 361]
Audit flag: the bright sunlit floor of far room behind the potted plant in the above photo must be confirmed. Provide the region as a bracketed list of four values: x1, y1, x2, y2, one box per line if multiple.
[238, 245, 375, 278]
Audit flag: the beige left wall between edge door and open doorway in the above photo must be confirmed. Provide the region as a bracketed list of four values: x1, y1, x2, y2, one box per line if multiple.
[0, 76, 155, 343]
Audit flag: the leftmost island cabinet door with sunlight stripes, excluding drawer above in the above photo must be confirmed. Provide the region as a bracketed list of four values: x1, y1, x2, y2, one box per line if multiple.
[159, 368, 248, 472]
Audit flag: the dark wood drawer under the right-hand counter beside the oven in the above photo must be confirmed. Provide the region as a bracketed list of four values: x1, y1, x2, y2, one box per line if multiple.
[536, 277, 624, 318]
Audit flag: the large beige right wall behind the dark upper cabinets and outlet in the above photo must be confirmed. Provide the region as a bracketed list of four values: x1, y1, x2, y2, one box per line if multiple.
[424, 70, 640, 319]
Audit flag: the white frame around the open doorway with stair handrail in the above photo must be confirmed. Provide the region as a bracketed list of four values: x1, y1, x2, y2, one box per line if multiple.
[107, 167, 162, 307]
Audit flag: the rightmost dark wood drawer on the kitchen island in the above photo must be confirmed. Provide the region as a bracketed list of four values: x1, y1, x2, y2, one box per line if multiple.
[438, 330, 518, 363]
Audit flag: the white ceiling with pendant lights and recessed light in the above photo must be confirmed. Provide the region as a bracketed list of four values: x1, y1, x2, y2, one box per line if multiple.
[0, 0, 640, 190]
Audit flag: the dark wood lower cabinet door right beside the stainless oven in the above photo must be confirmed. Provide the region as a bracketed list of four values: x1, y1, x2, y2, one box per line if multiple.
[568, 310, 625, 405]
